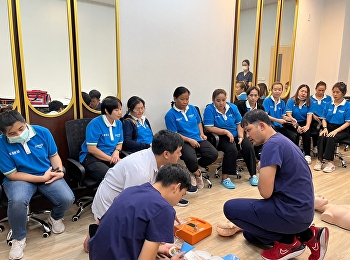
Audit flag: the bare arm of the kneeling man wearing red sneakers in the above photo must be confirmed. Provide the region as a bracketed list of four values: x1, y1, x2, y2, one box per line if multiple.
[258, 164, 277, 199]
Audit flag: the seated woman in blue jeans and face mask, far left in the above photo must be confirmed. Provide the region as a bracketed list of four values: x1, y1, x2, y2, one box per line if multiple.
[0, 110, 74, 259]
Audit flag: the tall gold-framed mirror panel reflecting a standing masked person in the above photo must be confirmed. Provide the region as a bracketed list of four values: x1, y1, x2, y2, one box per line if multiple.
[235, 0, 258, 95]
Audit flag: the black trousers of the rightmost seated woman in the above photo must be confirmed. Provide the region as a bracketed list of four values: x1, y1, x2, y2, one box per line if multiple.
[317, 122, 349, 161]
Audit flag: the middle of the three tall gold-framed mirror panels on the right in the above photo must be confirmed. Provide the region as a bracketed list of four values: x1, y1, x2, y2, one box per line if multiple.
[257, 0, 278, 88]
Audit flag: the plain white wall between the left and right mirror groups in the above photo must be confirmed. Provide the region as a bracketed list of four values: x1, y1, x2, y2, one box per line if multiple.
[119, 0, 234, 131]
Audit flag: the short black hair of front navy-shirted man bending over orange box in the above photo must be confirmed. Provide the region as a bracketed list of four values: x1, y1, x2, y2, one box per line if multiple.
[156, 163, 191, 190]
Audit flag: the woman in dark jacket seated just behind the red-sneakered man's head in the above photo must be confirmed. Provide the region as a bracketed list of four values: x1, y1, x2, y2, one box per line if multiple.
[235, 86, 266, 159]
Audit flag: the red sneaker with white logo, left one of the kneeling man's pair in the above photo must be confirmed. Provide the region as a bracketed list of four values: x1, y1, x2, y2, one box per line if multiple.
[261, 237, 305, 260]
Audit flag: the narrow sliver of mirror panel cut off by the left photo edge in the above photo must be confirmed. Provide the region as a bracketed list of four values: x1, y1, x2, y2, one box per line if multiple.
[0, 0, 16, 105]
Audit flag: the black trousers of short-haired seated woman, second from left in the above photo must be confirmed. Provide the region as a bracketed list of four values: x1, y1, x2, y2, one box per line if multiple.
[81, 153, 114, 182]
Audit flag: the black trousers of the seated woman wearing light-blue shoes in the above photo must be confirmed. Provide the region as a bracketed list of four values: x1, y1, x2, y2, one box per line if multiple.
[217, 135, 256, 176]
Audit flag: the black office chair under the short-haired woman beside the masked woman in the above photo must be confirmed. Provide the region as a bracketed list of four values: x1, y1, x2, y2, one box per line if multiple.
[65, 118, 96, 221]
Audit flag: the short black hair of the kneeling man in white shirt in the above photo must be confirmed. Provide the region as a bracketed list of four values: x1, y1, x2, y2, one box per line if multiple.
[152, 129, 184, 155]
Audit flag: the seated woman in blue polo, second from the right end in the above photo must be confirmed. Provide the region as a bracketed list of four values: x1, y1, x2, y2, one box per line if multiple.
[310, 81, 332, 155]
